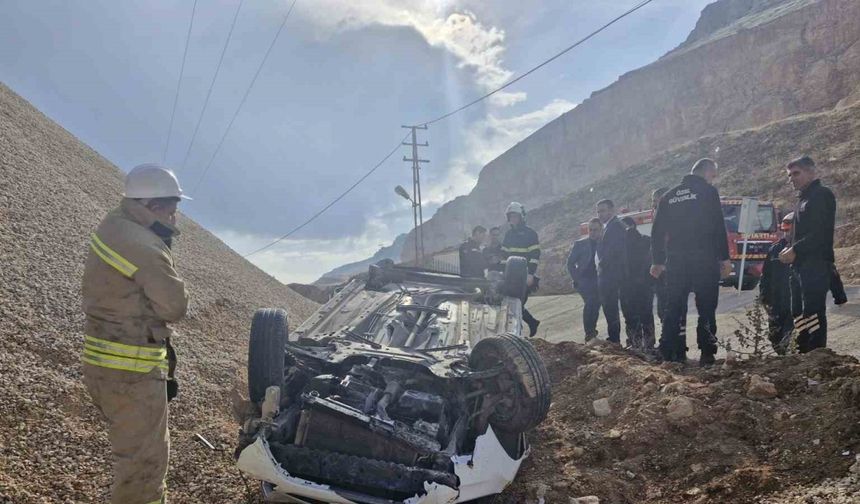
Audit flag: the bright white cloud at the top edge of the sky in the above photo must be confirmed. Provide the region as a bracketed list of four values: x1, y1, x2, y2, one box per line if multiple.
[296, 0, 526, 106]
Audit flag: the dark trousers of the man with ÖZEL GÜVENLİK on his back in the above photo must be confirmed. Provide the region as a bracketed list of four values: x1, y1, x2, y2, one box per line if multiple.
[660, 255, 720, 361]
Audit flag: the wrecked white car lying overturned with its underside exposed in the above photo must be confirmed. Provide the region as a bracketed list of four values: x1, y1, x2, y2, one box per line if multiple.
[236, 258, 550, 504]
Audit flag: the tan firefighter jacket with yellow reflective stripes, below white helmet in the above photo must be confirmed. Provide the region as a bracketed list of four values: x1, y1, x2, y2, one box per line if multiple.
[82, 198, 188, 379]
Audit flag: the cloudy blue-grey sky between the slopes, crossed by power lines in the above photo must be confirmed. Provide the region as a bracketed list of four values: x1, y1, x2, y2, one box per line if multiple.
[0, 0, 710, 282]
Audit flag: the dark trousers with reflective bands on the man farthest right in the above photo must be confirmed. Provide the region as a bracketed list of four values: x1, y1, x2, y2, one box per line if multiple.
[791, 259, 833, 353]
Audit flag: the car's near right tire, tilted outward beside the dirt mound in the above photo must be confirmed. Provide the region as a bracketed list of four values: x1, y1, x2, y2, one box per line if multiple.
[469, 334, 552, 433]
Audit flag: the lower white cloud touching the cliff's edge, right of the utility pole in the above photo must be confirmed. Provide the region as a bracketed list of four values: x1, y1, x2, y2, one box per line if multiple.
[425, 99, 576, 204]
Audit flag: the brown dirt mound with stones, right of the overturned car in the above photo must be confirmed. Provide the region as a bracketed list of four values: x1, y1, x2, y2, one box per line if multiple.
[494, 340, 860, 504]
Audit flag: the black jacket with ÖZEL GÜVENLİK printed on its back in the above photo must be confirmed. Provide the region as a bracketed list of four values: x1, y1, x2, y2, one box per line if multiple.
[651, 175, 729, 265]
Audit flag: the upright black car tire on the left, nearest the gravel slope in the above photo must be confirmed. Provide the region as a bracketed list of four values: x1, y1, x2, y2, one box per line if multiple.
[248, 308, 289, 403]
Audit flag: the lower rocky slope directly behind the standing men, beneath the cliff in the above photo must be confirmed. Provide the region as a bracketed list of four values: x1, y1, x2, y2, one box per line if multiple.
[529, 100, 860, 294]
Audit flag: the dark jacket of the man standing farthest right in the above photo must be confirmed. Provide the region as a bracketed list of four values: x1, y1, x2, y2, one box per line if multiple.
[792, 180, 836, 264]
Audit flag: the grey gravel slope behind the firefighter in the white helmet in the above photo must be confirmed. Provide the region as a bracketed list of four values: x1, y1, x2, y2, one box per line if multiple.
[0, 84, 316, 504]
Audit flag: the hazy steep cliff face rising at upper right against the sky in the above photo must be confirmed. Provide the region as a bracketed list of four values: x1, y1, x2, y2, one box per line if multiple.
[401, 0, 860, 260]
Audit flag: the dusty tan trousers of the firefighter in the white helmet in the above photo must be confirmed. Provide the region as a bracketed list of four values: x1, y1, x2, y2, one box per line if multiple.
[84, 365, 170, 504]
